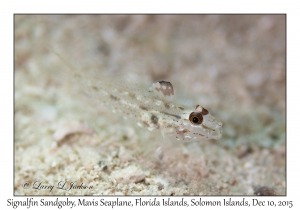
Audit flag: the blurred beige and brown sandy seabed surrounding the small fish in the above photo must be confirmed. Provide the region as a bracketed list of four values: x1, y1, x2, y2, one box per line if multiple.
[14, 15, 286, 195]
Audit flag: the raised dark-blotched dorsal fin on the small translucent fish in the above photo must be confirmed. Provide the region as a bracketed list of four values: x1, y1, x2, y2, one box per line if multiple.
[149, 81, 174, 101]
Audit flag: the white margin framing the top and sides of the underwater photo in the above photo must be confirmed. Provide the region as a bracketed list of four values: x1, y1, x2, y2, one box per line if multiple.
[0, 0, 300, 209]
